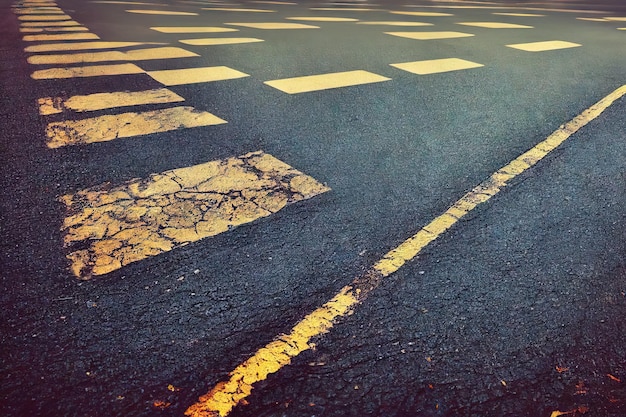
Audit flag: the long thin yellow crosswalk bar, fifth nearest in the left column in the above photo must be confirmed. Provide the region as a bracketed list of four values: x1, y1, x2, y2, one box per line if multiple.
[28, 47, 199, 65]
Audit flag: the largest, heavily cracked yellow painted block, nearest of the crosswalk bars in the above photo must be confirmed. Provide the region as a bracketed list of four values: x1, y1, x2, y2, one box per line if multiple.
[61, 151, 330, 279]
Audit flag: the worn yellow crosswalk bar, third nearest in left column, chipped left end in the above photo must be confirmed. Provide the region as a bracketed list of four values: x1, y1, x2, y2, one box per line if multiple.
[38, 88, 185, 116]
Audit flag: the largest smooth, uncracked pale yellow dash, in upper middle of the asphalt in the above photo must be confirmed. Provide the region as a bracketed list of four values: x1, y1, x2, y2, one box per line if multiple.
[265, 70, 391, 94]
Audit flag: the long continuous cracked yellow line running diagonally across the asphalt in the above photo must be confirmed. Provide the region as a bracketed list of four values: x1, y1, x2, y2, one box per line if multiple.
[185, 85, 626, 417]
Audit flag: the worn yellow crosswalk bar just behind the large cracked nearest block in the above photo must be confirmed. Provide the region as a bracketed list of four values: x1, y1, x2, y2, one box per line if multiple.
[46, 107, 226, 148]
